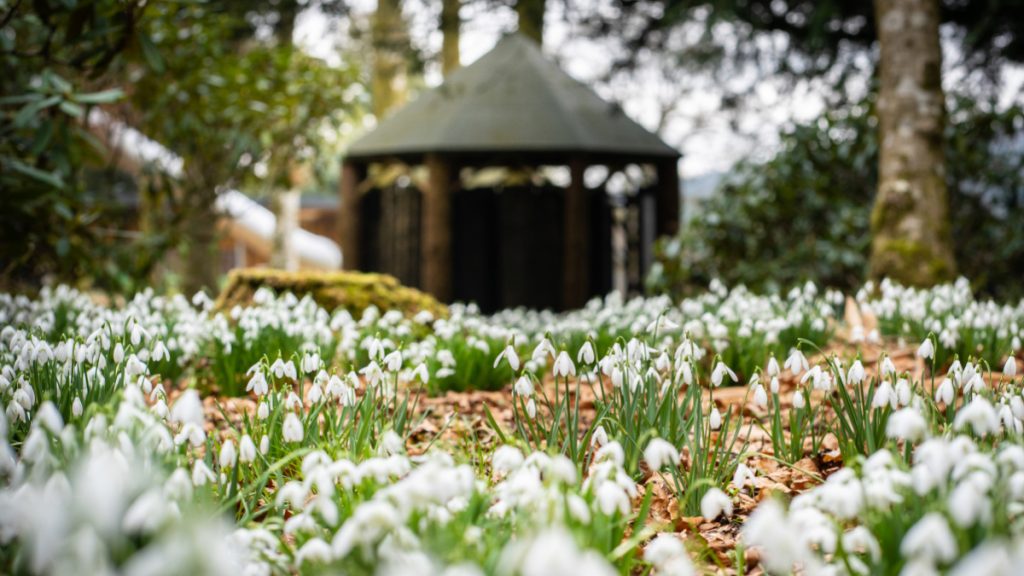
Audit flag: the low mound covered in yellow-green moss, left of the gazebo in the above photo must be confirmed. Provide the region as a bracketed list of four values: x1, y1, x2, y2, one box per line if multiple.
[217, 269, 447, 318]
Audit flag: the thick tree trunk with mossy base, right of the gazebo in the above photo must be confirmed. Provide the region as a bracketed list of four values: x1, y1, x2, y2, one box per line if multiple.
[870, 0, 956, 286]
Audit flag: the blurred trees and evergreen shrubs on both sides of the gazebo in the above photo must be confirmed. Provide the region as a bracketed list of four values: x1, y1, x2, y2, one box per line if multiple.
[0, 0, 1024, 301]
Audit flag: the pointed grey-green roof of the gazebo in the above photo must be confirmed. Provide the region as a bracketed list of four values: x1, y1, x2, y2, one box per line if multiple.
[347, 34, 679, 160]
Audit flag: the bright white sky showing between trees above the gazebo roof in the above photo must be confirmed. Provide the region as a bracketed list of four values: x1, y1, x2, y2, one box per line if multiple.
[295, 0, 1024, 178]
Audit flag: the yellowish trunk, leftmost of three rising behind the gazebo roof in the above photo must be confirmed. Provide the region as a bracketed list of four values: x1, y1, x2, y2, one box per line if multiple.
[373, 0, 409, 120]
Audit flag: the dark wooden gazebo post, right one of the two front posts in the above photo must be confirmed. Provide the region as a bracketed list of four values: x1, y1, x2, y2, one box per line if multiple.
[562, 158, 590, 310]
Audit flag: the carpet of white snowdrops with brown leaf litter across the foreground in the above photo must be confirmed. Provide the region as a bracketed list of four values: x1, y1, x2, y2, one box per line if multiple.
[0, 281, 1024, 576]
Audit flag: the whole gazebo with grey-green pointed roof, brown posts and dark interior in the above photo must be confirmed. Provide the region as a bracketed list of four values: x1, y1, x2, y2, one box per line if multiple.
[339, 35, 680, 312]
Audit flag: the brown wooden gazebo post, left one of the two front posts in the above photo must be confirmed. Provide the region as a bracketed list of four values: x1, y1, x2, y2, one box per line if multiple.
[420, 154, 453, 302]
